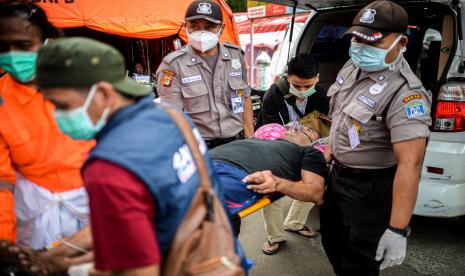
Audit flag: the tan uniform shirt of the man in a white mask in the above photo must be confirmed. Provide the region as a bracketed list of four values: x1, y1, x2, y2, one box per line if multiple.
[157, 43, 250, 140]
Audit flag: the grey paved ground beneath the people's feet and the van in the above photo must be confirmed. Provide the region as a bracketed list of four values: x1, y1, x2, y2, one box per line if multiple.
[240, 197, 465, 276]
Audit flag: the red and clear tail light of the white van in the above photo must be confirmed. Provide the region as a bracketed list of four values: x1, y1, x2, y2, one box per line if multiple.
[433, 82, 465, 132]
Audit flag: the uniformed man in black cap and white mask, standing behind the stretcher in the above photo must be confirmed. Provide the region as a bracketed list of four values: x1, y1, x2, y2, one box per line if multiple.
[157, 0, 253, 148]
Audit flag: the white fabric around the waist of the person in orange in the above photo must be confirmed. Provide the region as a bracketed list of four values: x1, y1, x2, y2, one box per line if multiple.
[15, 174, 89, 249]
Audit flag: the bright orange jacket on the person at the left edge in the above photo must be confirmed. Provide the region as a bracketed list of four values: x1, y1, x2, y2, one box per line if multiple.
[0, 74, 95, 241]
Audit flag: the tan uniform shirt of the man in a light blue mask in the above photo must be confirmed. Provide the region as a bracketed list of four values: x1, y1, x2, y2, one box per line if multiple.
[328, 58, 431, 169]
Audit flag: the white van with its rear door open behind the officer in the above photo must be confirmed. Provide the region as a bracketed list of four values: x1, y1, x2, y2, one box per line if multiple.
[262, 0, 465, 217]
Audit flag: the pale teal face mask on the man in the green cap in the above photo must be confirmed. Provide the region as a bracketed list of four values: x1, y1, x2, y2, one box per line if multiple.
[55, 85, 110, 140]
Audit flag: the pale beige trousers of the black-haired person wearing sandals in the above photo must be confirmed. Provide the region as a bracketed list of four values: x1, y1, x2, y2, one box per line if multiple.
[263, 197, 315, 242]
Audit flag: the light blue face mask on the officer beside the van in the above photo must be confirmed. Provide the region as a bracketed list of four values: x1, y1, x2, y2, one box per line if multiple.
[349, 35, 405, 72]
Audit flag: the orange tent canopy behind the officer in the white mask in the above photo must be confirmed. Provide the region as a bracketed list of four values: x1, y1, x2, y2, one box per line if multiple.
[33, 0, 240, 45]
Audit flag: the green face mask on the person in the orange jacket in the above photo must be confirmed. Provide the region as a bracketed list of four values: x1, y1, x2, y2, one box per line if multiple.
[0, 51, 37, 83]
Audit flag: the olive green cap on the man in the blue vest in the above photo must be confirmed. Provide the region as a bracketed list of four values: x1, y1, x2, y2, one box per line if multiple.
[35, 37, 152, 96]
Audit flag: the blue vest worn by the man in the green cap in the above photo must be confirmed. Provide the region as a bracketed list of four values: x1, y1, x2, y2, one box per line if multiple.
[86, 97, 222, 256]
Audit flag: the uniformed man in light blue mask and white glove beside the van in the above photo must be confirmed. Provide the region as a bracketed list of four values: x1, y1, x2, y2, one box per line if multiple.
[321, 1, 431, 275]
